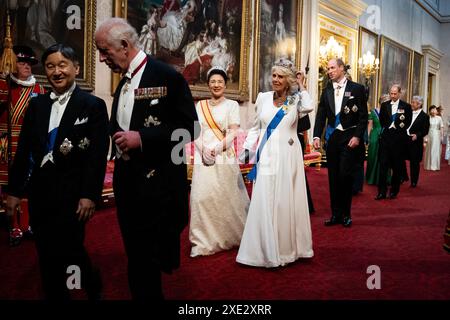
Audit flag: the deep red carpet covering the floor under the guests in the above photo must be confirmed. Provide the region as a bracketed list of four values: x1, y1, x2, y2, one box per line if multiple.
[0, 161, 450, 300]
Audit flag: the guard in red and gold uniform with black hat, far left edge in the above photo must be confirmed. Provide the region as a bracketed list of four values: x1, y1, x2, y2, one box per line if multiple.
[0, 46, 45, 245]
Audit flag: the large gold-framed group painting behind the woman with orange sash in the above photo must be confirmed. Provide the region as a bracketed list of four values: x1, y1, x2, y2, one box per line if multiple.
[112, 0, 250, 101]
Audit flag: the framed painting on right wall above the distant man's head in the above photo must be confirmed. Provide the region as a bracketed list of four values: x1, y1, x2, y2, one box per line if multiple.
[378, 36, 413, 101]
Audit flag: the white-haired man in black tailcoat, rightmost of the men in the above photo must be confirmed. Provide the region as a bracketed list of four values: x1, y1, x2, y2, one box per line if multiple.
[407, 96, 430, 188]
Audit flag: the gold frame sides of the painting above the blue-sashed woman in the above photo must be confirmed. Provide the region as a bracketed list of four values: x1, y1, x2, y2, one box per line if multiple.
[252, 0, 303, 102]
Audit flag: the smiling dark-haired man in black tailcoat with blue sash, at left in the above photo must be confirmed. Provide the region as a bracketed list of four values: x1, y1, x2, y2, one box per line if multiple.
[7, 44, 109, 300]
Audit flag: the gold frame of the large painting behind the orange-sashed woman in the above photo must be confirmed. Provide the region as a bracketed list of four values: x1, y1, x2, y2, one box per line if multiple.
[111, 0, 251, 101]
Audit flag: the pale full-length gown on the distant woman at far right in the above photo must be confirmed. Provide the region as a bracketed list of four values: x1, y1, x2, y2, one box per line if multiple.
[424, 116, 444, 171]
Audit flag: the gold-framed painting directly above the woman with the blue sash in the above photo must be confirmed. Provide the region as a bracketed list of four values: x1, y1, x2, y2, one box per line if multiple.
[252, 0, 303, 101]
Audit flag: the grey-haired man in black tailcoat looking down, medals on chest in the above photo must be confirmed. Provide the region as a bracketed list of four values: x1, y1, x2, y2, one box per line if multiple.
[95, 18, 200, 300]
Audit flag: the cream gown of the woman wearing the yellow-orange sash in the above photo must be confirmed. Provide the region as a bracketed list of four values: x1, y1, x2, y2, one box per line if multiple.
[189, 99, 250, 257]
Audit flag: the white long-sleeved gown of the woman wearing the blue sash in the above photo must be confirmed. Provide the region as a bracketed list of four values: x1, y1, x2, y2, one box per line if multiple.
[236, 91, 314, 267]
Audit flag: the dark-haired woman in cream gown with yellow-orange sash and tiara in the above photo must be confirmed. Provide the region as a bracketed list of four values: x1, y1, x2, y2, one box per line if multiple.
[189, 67, 250, 257]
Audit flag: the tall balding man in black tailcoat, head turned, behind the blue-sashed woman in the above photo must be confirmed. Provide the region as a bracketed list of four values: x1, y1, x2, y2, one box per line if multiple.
[314, 59, 368, 227]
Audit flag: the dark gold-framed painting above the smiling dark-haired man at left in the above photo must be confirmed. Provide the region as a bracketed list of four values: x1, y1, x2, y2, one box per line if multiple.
[0, 0, 97, 91]
